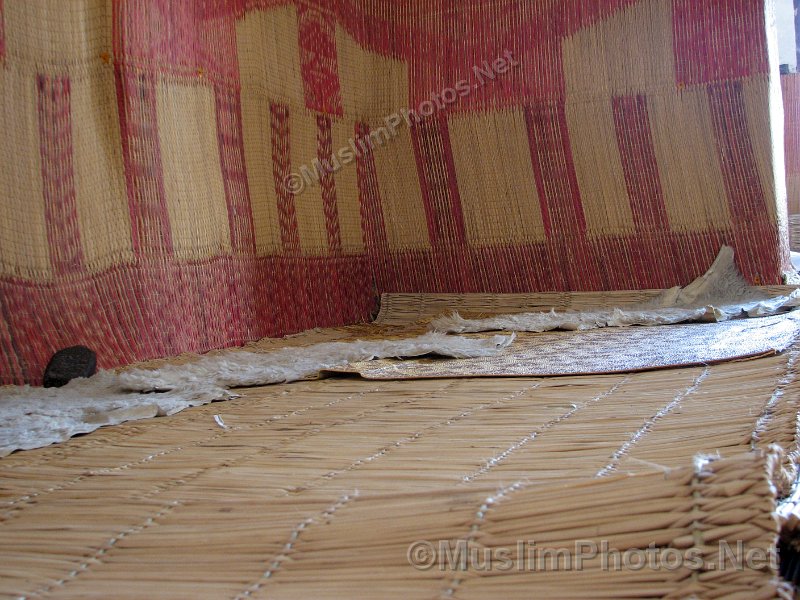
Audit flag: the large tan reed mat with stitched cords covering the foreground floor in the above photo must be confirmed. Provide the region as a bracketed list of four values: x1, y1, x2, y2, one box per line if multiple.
[0, 348, 800, 598]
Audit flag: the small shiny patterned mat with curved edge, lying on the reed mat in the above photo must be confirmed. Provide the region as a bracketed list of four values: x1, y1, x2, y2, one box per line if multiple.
[332, 316, 800, 379]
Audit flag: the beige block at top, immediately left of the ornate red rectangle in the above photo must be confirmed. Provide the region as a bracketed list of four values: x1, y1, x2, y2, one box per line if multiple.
[236, 5, 305, 106]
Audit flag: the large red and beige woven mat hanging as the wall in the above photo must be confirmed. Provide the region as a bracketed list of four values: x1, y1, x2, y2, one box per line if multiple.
[0, 0, 788, 383]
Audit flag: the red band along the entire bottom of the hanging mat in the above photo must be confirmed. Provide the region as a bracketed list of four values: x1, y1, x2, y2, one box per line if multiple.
[0, 224, 779, 384]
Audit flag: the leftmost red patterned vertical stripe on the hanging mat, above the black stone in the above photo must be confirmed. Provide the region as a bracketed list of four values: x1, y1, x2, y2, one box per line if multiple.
[36, 75, 83, 275]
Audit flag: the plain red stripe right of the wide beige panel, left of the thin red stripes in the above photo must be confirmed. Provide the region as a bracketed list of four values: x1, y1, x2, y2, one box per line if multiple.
[214, 85, 256, 254]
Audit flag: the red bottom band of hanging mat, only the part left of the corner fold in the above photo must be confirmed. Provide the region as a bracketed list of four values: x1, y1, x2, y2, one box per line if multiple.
[0, 257, 375, 385]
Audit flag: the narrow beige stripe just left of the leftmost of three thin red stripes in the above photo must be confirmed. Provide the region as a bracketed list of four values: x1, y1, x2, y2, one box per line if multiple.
[241, 85, 282, 256]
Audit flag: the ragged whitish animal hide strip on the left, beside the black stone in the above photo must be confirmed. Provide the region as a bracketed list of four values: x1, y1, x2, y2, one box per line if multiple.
[0, 333, 514, 456]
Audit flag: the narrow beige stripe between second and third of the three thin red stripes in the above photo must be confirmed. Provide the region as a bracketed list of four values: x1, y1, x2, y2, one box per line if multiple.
[331, 119, 364, 254]
